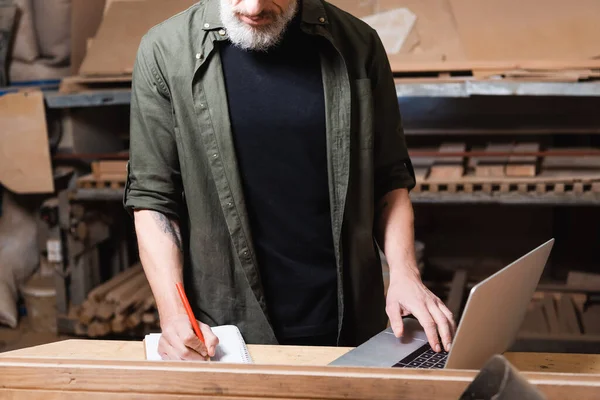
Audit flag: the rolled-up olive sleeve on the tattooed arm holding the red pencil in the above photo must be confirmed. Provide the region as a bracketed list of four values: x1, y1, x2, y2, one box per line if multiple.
[123, 37, 182, 218]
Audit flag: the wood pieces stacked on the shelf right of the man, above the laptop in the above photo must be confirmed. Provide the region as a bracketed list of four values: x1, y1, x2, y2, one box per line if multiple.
[410, 143, 600, 196]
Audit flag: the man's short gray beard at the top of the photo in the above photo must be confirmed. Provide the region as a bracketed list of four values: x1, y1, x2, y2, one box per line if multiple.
[220, 0, 298, 51]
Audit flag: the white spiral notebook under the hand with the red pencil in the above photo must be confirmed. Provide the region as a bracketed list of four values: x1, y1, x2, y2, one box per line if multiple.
[144, 325, 253, 364]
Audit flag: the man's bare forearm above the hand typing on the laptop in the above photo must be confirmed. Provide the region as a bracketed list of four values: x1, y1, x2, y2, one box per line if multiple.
[375, 189, 420, 280]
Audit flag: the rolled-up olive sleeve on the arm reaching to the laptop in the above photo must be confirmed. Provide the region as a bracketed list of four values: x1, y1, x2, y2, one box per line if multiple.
[371, 33, 416, 201]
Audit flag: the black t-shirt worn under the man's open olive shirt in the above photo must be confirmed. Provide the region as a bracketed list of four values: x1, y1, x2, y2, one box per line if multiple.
[220, 21, 338, 341]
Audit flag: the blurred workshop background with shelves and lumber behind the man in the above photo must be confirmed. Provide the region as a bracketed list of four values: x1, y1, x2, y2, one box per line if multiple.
[0, 0, 600, 353]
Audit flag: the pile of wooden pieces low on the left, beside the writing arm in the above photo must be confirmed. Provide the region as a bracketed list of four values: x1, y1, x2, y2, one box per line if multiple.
[71, 264, 158, 337]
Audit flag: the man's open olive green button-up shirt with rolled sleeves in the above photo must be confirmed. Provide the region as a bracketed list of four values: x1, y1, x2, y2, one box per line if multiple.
[123, 0, 415, 345]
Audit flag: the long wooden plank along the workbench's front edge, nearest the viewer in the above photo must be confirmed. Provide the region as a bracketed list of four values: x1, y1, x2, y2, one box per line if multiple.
[0, 358, 600, 400]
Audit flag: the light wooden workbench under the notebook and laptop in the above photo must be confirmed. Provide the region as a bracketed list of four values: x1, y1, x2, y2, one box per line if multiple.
[0, 340, 600, 400]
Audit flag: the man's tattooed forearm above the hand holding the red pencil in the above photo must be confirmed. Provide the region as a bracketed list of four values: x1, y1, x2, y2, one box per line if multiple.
[134, 210, 185, 321]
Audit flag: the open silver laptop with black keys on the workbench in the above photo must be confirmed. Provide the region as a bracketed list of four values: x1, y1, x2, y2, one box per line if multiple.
[329, 239, 554, 370]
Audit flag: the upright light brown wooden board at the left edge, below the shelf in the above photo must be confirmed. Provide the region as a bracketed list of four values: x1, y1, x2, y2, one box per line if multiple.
[0, 91, 54, 194]
